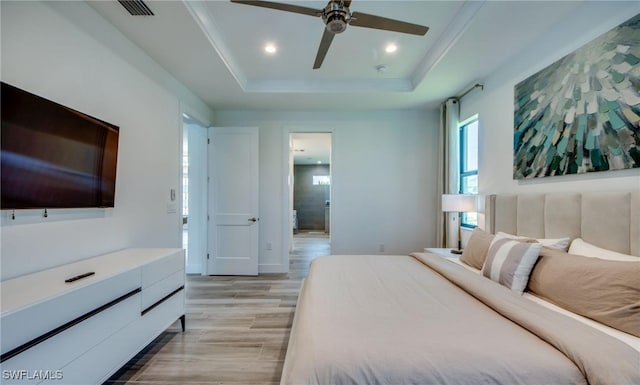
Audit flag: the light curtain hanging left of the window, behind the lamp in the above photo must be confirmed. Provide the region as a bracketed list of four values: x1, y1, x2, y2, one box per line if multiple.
[436, 98, 460, 248]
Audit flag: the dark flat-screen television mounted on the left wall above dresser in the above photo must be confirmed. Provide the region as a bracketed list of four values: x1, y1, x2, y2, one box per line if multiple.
[0, 79, 119, 210]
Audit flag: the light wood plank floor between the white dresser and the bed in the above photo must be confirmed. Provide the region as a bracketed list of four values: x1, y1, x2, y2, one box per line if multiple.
[105, 234, 330, 385]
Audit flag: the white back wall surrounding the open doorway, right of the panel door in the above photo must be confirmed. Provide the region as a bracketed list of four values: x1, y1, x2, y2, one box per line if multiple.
[215, 111, 439, 272]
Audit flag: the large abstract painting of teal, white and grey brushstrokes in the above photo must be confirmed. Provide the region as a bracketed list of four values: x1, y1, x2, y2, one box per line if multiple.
[513, 14, 640, 179]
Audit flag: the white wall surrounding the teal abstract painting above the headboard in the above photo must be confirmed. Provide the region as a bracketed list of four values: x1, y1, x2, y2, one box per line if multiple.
[461, 1, 640, 194]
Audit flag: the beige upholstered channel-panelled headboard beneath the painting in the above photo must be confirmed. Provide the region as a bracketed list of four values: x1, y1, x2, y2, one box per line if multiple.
[485, 191, 640, 256]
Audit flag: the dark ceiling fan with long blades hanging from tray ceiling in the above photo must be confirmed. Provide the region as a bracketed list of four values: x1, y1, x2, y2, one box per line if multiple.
[231, 0, 429, 69]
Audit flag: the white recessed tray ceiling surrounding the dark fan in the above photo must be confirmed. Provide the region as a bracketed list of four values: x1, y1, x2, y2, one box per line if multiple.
[88, 0, 579, 111]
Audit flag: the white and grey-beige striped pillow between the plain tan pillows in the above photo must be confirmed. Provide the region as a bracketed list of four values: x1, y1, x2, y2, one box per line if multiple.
[482, 237, 542, 293]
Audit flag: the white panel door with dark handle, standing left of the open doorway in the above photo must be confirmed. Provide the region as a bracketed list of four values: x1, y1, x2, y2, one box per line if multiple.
[207, 127, 259, 275]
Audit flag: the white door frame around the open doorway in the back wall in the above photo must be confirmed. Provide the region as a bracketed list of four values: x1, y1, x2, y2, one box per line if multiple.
[282, 126, 335, 272]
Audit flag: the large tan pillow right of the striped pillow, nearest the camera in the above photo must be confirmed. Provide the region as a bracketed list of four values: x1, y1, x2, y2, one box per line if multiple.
[529, 248, 640, 337]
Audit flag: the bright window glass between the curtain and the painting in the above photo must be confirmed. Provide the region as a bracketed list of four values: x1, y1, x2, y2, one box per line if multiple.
[460, 116, 478, 227]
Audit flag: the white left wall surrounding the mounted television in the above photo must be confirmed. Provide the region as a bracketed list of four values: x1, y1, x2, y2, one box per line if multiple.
[0, 1, 212, 280]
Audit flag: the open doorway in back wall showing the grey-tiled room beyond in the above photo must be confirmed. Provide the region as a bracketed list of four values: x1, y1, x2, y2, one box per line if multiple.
[289, 132, 332, 256]
